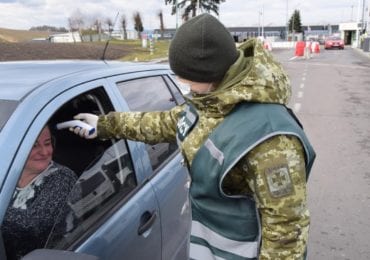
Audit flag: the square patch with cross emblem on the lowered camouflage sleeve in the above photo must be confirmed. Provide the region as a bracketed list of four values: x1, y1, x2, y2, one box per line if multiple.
[265, 165, 294, 198]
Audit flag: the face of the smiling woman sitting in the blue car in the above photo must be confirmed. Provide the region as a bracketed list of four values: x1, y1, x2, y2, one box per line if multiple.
[24, 127, 53, 174]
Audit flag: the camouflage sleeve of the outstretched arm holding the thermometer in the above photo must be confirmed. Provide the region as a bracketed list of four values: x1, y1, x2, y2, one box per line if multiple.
[97, 106, 182, 143]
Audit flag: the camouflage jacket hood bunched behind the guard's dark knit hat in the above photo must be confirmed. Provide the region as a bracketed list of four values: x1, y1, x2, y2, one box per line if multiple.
[188, 39, 291, 118]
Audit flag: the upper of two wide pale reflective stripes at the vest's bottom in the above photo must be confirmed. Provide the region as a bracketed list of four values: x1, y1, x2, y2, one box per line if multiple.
[191, 220, 258, 258]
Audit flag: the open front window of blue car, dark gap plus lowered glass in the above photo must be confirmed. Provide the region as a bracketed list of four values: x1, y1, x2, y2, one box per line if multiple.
[46, 88, 137, 249]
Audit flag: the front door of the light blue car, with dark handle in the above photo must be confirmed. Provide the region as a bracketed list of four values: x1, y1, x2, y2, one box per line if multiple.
[0, 80, 162, 259]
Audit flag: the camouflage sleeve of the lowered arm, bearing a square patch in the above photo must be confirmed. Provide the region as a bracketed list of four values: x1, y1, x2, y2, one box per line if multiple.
[245, 135, 309, 259]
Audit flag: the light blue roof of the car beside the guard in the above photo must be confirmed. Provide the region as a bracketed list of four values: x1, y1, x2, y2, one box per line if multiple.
[0, 60, 168, 101]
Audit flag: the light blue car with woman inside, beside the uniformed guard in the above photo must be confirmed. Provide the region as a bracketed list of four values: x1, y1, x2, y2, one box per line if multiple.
[0, 60, 191, 260]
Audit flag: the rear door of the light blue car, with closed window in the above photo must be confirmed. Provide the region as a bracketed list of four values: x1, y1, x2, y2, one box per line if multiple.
[105, 71, 191, 259]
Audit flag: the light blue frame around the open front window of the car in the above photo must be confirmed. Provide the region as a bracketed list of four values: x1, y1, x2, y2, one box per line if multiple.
[0, 79, 152, 255]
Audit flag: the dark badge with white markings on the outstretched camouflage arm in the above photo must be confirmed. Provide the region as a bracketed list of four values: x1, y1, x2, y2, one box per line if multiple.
[177, 104, 199, 141]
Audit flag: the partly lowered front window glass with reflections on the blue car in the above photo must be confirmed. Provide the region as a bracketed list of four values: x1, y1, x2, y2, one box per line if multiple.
[46, 140, 137, 249]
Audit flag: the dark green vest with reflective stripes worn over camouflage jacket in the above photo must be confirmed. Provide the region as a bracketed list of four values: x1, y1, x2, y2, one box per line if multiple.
[190, 103, 315, 260]
